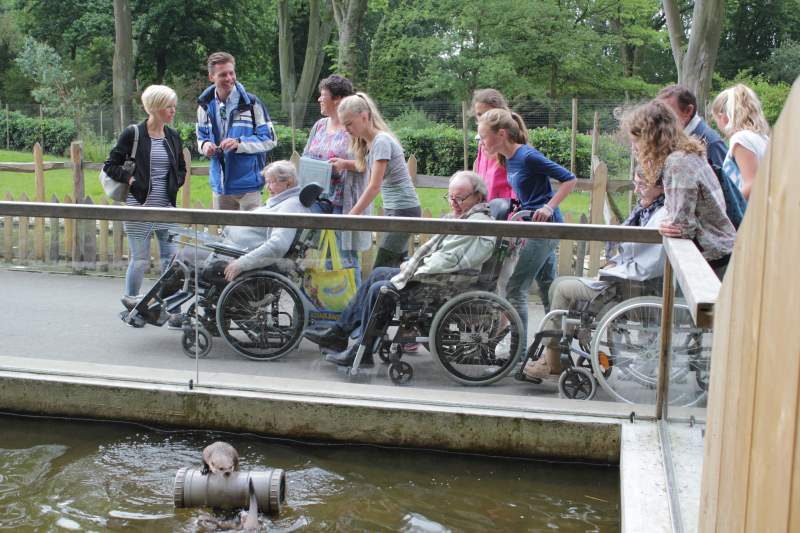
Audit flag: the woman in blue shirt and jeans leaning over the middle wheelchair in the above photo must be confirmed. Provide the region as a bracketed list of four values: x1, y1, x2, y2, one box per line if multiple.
[478, 109, 576, 373]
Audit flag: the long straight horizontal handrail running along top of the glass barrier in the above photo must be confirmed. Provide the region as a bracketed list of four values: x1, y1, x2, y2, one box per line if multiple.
[0, 201, 661, 243]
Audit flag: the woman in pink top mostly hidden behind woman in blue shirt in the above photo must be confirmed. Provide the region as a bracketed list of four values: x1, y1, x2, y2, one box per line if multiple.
[472, 89, 556, 312]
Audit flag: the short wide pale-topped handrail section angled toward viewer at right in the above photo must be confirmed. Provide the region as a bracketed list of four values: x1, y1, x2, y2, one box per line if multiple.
[664, 237, 722, 328]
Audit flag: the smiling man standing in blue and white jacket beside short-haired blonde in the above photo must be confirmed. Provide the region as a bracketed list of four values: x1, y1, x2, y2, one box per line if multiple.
[197, 52, 277, 211]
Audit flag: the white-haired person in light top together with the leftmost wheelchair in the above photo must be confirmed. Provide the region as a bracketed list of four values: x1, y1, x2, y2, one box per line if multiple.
[121, 161, 329, 360]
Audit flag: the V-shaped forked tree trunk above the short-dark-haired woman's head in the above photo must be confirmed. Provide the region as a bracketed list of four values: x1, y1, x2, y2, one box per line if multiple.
[278, 0, 333, 126]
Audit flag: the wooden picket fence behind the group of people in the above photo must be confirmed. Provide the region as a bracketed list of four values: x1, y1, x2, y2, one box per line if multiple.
[0, 114, 631, 275]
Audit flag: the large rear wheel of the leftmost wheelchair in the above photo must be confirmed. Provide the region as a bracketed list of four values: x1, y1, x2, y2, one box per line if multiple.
[217, 271, 305, 361]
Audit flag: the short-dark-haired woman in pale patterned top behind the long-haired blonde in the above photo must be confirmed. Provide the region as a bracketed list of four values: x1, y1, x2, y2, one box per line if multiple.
[303, 75, 372, 284]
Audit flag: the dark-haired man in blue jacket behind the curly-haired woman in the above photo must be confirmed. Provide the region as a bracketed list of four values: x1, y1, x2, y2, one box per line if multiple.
[656, 85, 747, 230]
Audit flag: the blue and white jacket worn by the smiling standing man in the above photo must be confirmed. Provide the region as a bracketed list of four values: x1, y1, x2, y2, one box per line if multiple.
[196, 82, 278, 194]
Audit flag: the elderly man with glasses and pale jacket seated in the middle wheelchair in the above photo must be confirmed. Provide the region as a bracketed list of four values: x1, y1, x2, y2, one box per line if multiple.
[305, 171, 495, 366]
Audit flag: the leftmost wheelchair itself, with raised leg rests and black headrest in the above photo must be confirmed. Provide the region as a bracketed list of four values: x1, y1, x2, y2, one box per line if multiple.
[122, 183, 336, 361]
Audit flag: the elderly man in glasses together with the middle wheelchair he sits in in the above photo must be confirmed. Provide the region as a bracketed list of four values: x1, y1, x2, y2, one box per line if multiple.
[305, 171, 521, 384]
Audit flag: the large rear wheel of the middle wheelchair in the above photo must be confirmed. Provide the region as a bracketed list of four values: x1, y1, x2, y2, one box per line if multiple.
[430, 291, 524, 385]
